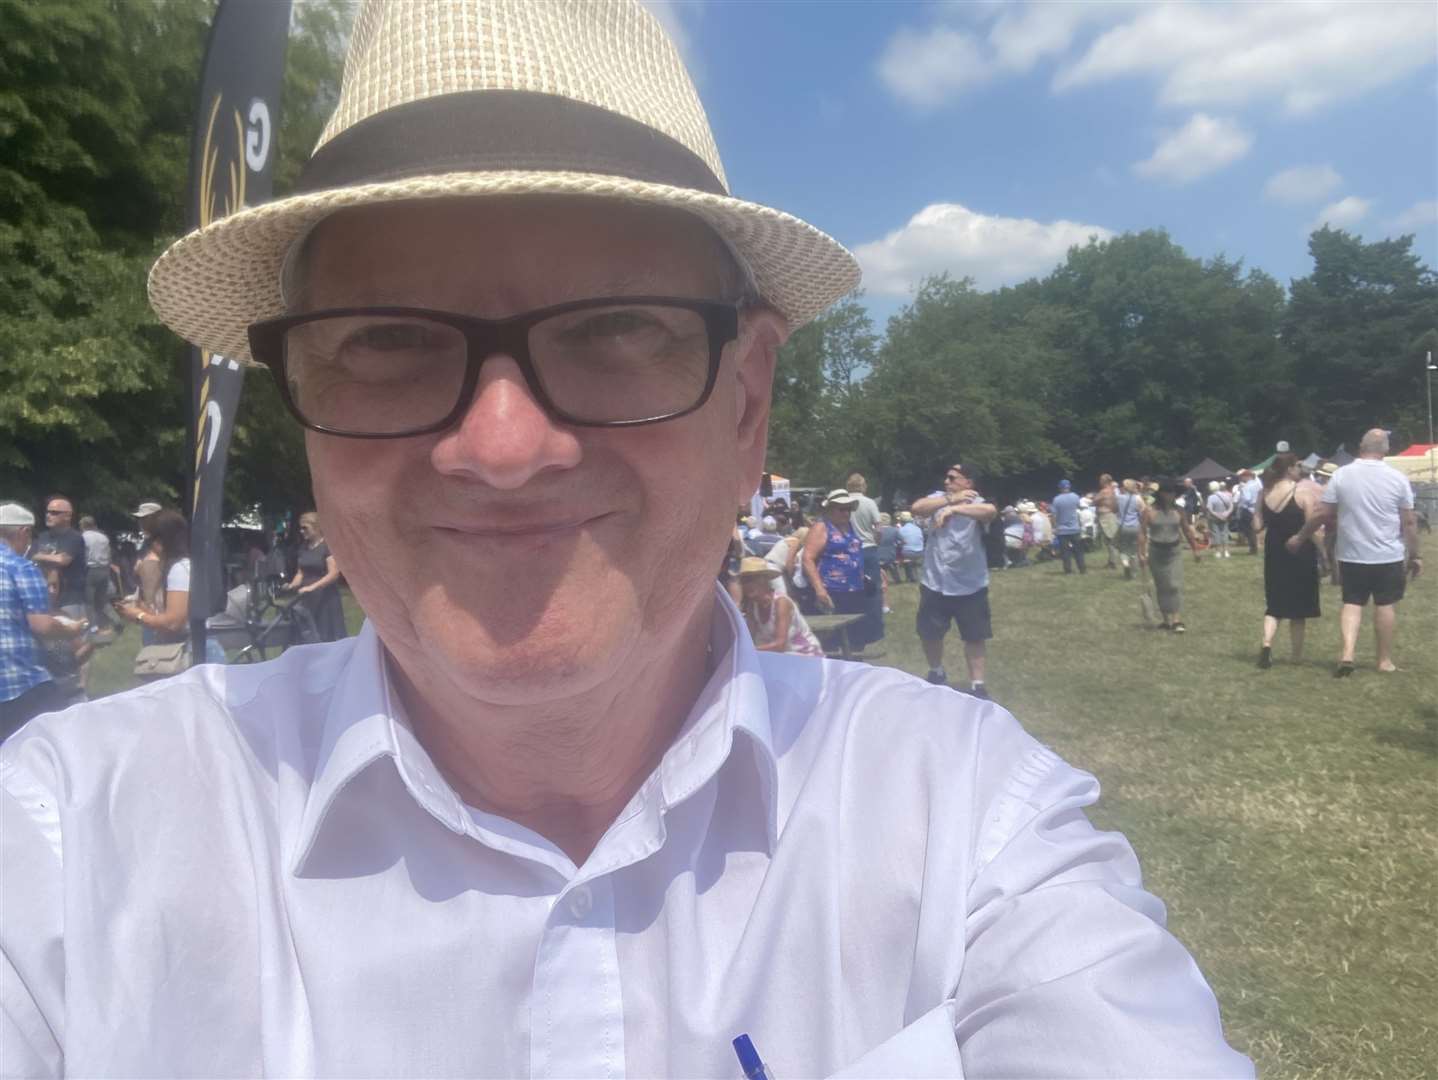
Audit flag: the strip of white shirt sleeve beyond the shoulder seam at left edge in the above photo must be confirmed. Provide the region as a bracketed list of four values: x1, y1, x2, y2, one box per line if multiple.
[0, 764, 65, 1079]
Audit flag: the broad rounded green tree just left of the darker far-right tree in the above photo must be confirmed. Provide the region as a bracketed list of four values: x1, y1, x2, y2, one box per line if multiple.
[1041, 232, 1301, 473]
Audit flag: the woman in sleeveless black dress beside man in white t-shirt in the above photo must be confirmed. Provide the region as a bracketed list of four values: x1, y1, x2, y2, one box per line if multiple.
[1254, 453, 1320, 667]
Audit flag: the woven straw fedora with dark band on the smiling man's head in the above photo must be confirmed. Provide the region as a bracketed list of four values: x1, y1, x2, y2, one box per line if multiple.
[150, 0, 858, 361]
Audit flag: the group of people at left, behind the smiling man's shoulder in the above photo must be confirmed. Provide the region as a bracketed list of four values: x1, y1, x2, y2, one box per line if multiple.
[0, 495, 345, 741]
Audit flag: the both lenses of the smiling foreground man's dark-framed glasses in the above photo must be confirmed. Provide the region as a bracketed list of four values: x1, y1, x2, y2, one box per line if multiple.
[285, 305, 709, 434]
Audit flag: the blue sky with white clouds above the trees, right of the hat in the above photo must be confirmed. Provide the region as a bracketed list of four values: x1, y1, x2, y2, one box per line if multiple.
[650, 0, 1438, 325]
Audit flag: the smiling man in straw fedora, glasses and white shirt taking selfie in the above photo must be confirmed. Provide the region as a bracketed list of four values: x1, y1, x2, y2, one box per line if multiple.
[0, 0, 1251, 1077]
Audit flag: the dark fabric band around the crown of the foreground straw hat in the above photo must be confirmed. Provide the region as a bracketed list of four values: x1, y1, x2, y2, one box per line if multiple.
[295, 91, 728, 196]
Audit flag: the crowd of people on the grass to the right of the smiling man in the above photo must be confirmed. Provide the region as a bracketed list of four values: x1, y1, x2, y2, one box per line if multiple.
[725, 429, 1422, 687]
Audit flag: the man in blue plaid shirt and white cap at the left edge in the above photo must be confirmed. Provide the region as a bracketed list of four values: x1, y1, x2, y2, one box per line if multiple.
[0, 502, 85, 742]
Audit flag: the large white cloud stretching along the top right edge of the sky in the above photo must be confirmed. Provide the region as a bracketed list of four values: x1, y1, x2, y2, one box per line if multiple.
[879, 0, 1438, 114]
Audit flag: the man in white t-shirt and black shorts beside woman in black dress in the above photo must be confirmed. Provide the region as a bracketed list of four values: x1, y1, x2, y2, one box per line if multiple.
[1288, 427, 1424, 679]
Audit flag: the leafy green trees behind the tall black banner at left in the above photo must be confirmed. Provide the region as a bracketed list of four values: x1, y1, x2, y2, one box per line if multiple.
[0, 0, 351, 525]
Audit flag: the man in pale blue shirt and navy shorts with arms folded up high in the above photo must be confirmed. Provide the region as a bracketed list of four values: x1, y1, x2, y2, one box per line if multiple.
[910, 465, 998, 697]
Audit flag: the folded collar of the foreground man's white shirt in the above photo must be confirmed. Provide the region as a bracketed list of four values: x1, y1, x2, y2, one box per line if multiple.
[290, 585, 778, 874]
